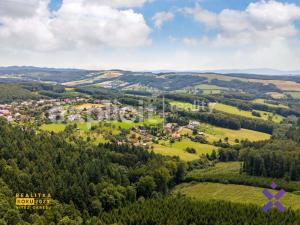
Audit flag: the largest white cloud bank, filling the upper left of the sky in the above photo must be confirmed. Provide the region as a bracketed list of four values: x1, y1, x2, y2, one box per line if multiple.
[0, 0, 151, 51]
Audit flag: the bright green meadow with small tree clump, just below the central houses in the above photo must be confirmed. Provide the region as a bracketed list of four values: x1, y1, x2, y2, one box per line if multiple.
[153, 139, 216, 161]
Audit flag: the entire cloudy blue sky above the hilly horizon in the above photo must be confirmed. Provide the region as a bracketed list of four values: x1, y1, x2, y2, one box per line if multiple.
[0, 0, 300, 71]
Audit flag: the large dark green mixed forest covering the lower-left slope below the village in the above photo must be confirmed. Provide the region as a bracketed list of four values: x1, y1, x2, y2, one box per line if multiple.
[0, 120, 185, 225]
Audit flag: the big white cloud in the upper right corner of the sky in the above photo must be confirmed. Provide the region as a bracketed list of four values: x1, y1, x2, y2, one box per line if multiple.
[185, 0, 300, 46]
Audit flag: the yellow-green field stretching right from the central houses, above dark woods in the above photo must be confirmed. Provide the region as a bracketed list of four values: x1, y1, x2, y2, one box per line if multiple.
[199, 123, 271, 144]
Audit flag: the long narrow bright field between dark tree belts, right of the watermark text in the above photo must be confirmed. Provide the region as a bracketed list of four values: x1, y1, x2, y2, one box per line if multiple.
[210, 103, 284, 123]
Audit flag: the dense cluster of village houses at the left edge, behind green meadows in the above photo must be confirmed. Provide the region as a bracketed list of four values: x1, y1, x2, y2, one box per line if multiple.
[0, 97, 138, 123]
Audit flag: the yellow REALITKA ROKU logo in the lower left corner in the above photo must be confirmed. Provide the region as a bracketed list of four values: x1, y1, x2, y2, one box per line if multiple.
[16, 193, 51, 209]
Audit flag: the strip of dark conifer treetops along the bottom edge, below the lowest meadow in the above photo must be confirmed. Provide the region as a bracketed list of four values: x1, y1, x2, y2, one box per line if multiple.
[98, 197, 300, 225]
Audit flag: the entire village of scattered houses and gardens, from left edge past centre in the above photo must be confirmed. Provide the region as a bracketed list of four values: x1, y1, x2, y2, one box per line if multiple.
[0, 97, 211, 155]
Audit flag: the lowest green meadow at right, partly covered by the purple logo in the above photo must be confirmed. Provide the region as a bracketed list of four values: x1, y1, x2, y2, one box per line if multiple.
[174, 183, 300, 209]
